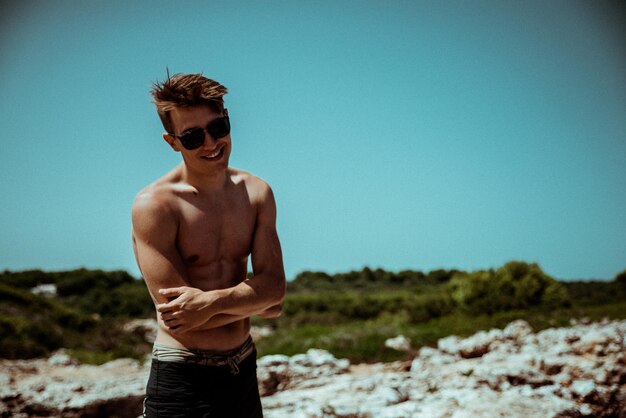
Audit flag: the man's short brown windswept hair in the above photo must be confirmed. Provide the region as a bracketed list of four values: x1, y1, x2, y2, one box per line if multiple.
[150, 73, 228, 134]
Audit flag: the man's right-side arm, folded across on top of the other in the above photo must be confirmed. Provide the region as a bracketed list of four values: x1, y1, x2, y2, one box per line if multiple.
[157, 180, 285, 324]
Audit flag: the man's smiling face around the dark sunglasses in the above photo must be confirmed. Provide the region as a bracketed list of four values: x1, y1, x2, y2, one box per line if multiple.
[163, 106, 231, 168]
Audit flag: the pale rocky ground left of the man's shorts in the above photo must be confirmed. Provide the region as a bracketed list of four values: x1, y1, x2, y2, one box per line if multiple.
[0, 351, 149, 418]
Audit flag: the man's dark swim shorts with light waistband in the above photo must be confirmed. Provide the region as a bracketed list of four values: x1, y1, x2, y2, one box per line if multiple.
[143, 339, 263, 418]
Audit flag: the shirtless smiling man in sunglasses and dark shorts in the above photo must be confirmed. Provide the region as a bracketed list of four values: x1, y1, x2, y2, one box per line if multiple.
[132, 74, 285, 418]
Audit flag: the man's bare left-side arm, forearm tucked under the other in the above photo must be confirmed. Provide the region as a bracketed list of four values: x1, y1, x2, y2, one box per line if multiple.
[132, 192, 243, 332]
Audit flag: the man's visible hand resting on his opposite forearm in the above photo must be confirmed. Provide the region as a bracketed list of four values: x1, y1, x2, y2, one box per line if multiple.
[157, 286, 216, 334]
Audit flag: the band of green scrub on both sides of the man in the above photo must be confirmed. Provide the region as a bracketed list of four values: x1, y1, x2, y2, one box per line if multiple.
[0, 261, 626, 362]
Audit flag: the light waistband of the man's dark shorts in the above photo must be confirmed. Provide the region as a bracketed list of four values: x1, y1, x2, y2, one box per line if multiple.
[152, 337, 255, 374]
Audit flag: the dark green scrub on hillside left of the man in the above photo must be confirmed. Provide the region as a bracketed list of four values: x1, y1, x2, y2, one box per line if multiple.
[0, 269, 154, 362]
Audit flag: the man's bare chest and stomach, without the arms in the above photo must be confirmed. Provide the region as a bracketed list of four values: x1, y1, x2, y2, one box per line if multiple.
[140, 169, 257, 351]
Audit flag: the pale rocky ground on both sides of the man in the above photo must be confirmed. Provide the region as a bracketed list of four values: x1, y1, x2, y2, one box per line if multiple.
[0, 321, 626, 418]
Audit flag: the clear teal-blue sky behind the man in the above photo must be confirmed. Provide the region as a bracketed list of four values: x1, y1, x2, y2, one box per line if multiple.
[0, 0, 626, 279]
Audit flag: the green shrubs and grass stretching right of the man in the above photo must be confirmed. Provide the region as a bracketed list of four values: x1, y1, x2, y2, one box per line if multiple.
[254, 261, 626, 361]
